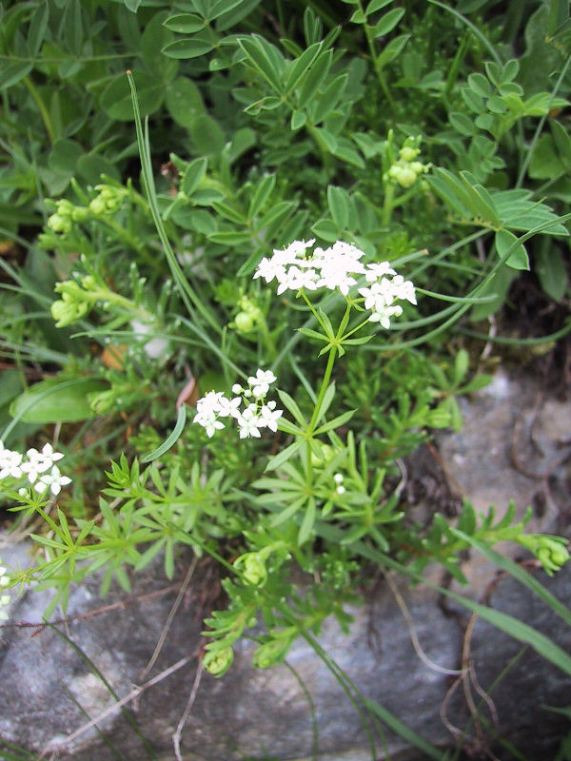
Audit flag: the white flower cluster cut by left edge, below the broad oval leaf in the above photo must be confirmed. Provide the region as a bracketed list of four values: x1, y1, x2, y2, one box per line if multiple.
[0, 441, 71, 497]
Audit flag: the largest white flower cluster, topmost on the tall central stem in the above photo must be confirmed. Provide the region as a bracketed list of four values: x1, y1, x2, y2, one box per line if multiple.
[254, 240, 416, 329]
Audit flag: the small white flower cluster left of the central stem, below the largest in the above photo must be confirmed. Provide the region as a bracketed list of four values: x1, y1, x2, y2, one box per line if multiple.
[193, 370, 283, 439]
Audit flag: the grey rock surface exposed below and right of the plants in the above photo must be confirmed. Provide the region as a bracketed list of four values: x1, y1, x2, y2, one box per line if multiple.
[0, 370, 571, 761]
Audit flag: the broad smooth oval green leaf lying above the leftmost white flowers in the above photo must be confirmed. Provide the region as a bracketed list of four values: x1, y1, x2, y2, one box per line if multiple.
[10, 378, 109, 424]
